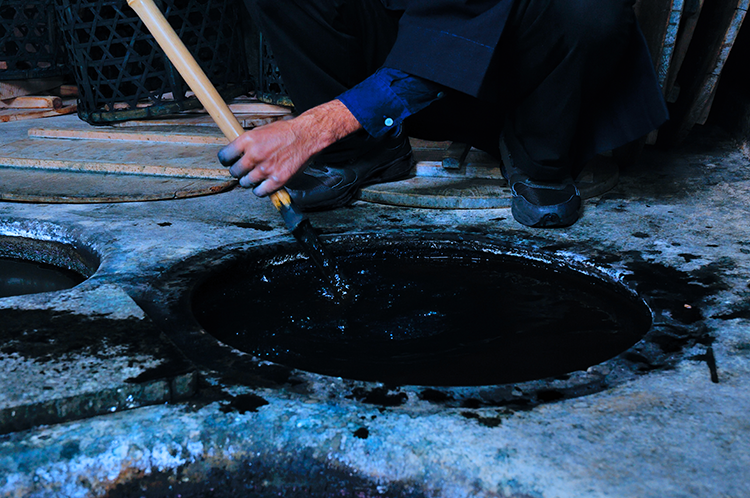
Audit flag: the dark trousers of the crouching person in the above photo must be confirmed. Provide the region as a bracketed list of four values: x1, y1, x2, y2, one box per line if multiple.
[245, 0, 635, 180]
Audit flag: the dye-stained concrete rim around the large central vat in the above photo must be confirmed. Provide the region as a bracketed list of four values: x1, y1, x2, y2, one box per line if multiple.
[131, 229, 724, 407]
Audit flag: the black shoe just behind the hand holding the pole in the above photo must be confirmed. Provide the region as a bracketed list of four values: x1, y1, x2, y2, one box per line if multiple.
[286, 136, 412, 211]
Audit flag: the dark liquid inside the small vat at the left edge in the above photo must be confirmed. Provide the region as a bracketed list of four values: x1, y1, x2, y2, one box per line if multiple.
[0, 258, 85, 297]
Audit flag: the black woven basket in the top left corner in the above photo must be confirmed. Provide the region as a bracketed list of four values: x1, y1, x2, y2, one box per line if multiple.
[0, 0, 68, 80]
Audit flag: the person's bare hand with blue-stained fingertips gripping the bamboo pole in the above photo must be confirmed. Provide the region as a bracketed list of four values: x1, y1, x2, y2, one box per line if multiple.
[219, 100, 361, 197]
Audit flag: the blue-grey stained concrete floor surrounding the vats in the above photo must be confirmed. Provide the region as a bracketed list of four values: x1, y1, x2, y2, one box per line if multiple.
[0, 118, 750, 498]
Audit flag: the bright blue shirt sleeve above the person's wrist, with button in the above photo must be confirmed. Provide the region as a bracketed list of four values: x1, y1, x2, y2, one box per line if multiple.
[338, 67, 444, 137]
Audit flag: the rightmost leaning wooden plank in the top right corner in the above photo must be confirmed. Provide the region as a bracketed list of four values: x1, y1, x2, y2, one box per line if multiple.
[665, 0, 750, 143]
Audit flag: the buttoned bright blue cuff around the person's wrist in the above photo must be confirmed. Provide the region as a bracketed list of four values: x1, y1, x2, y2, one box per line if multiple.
[338, 70, 411, 137]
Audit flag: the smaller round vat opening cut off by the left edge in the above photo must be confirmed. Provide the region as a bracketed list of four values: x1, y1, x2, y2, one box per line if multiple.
[0, 236, 99, 298]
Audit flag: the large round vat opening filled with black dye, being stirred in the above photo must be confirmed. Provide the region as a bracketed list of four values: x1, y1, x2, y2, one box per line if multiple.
[192, 239, 651, 386]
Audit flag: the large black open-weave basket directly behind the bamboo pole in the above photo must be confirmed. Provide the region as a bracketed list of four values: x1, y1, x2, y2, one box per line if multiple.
[57, 0, 250, 124]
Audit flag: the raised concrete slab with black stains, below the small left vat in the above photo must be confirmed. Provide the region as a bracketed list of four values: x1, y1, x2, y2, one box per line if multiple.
[0, 286, 195, 434]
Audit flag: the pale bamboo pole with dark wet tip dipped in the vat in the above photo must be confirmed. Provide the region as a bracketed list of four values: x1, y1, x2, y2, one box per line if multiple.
[127, 0, 351, 300]
